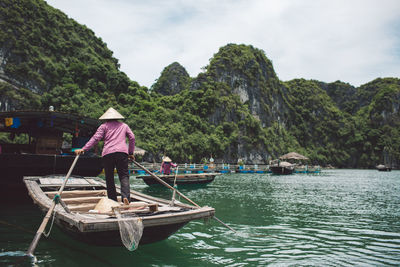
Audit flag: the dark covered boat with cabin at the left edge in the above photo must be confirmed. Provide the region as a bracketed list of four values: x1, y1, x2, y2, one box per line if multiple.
[0, 110, 102, 184]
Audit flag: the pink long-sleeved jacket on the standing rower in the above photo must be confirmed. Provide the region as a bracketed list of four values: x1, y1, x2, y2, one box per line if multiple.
[82, 121, 135, 156]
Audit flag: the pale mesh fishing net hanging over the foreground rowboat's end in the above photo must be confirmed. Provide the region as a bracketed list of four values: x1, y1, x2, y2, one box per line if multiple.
[115, 210, 143, 251]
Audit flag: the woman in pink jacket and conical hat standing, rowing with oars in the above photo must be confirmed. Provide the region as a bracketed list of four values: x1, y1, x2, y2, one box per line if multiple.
[75, 108, 135, 202]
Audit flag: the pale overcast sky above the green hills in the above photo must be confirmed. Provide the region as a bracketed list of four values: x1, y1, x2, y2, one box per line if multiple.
[47, 0, 400, 87]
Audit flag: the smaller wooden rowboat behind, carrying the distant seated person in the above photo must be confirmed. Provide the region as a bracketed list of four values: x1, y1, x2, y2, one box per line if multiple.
[136, 173, 221, 185]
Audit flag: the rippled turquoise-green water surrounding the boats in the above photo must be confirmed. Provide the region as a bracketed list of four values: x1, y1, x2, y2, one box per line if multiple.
[0, 170, 400, 266]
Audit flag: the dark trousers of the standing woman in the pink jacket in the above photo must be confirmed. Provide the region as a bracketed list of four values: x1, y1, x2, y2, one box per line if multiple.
[103, 152, 131, 202]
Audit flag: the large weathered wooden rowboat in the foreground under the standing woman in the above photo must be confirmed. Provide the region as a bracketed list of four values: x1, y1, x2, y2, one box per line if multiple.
[23, 176, 215, 246]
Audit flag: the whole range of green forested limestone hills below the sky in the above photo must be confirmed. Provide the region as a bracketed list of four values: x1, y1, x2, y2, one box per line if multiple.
[0, 0, 400, 168]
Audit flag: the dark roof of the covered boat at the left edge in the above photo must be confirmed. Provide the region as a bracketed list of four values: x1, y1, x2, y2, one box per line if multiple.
[0, 110, 100, 136]
